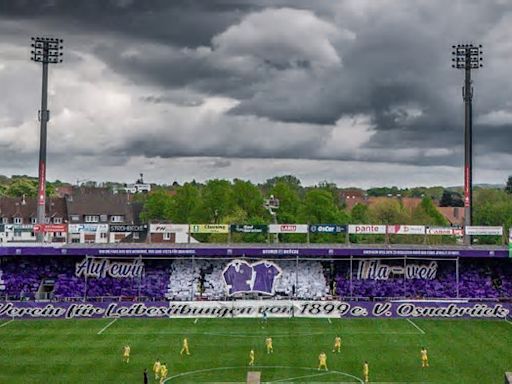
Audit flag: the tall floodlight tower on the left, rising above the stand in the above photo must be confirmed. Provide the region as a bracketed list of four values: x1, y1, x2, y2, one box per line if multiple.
[30, 37, 64, 242]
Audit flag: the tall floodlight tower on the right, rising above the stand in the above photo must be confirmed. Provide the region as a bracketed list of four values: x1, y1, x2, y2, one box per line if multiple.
[452, 44, 483, 245]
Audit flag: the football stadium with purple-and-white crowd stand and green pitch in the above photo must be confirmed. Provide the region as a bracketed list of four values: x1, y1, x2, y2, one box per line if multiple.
[0, 237, 512, 383]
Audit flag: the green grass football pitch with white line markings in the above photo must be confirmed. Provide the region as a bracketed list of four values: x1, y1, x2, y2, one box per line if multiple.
[0, 318, 512, 384]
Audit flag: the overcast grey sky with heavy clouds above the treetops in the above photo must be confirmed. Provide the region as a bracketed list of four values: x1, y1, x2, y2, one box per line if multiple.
[0, 0, 512, 187]
